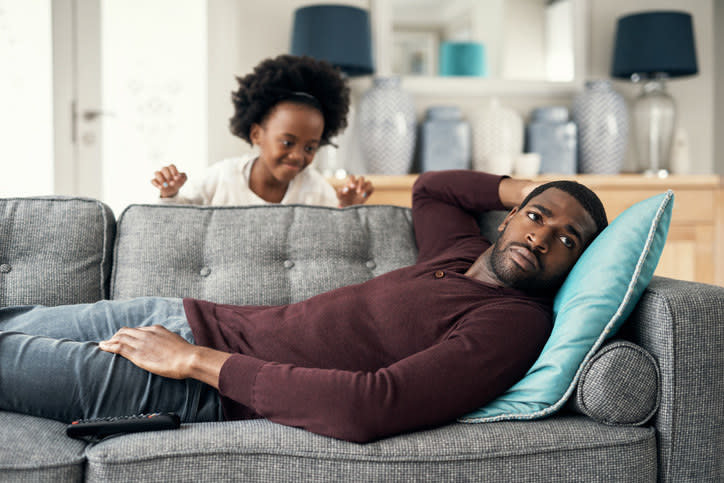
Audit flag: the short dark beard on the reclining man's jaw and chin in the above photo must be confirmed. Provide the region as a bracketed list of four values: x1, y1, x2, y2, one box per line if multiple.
[488, 241, 566, 295]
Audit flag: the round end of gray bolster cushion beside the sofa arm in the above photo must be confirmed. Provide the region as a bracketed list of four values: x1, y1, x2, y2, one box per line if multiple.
[571, 340, 659, 426]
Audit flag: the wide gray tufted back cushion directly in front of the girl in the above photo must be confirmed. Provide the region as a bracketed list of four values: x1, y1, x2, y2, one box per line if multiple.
[110, 205, 417, 305]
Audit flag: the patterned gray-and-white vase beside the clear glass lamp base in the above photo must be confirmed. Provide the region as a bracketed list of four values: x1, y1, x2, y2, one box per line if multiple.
[573, 80, 628, 174]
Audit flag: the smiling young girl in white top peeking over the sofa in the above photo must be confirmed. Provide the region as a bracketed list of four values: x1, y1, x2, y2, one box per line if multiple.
[151, 55, 373, 207]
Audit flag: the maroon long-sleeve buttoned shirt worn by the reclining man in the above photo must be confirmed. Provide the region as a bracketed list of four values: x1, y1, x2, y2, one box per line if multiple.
[184, 171, 551, 442]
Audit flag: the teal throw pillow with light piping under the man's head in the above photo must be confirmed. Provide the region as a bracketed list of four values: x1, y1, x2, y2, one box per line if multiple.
[460, 190, 674, 423]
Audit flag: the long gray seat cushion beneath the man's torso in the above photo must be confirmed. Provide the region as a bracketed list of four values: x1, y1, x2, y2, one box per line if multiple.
[87, 415, 657, 483]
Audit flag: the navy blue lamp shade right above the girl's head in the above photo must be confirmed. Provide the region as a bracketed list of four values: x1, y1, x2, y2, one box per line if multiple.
[290, 5, 374, 77]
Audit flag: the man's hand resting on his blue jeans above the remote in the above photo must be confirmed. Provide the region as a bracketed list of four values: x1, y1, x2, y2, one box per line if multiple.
[98, 325, 230, 388]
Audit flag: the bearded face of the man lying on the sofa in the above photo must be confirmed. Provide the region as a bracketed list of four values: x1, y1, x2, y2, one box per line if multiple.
[489, 188, 596, 293]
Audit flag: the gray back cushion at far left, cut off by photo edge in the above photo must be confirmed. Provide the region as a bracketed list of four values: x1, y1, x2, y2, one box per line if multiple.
[0, 197, 115, 307]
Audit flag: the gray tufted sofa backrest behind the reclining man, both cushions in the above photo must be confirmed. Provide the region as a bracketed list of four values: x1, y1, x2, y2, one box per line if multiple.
[0, 196, 504, 307]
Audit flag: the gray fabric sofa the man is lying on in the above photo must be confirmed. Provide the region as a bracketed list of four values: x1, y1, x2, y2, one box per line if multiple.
[0, 197, 724, 482]
